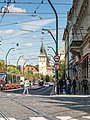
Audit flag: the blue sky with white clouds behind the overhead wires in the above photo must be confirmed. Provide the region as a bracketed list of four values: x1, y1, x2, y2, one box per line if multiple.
[0, 0, 72, 65]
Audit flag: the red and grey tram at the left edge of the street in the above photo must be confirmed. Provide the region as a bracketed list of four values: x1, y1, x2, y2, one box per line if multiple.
[0, 72, 22, 90]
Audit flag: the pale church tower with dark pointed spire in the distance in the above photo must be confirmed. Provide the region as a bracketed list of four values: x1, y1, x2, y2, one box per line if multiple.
[38, 42, 47, 75]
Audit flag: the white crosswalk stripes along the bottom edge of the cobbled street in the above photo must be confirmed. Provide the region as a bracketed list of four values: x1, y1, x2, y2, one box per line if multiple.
[0, 116, 90, 120]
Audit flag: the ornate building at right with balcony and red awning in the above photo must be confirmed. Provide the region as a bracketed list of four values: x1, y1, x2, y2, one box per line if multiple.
[63, 0, 90, 81]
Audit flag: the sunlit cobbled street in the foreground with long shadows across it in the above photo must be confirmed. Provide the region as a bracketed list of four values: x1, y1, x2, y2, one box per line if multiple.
[0, 92, 90, 120]
